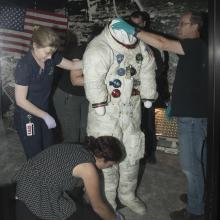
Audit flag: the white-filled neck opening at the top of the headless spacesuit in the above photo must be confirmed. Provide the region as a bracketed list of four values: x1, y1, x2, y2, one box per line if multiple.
[108, 19, 138, 46]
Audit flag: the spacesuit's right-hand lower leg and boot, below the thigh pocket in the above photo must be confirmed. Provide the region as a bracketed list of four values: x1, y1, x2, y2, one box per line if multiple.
[118, 161, 147, 215]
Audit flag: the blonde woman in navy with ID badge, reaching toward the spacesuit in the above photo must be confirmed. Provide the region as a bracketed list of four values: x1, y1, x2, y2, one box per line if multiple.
[15, 27, 81, 159]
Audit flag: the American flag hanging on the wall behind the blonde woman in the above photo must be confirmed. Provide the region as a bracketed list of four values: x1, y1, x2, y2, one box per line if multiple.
[0, 6, 67, 54]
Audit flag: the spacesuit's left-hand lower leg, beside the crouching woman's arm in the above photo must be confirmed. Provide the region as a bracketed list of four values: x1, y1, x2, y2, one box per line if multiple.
[102, 165, 119, 211]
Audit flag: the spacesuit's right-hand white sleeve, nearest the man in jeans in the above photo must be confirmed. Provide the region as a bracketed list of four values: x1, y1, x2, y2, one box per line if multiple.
[140, 45, 158, 101]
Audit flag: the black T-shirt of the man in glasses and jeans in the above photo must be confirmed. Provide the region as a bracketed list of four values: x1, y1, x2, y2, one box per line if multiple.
[171, 38, 208, 118]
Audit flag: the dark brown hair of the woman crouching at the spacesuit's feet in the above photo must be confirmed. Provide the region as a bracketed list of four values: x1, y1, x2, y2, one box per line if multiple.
[85, 136, 125, 162]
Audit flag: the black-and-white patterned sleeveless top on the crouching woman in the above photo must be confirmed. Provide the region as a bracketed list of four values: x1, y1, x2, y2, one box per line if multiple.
[14, 144, 95, 220]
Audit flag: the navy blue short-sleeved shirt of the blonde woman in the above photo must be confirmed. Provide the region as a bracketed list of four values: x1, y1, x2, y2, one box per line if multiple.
[15, 51, 63, 111]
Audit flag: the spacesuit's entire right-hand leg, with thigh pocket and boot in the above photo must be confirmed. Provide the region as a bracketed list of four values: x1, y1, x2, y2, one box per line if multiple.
[118, 113, 147, 215]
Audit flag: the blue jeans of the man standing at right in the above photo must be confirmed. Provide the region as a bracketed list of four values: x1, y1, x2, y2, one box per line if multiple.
[177, 117, 207, 215]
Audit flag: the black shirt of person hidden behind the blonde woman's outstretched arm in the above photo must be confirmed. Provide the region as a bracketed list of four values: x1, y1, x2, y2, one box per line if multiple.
[57, 46, 85, 96]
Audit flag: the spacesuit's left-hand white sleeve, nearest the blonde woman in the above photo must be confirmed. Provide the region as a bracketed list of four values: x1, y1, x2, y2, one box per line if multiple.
[83, 41, 112, 107]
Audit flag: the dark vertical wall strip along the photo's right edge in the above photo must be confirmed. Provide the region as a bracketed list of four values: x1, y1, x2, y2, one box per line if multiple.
[206, 0, 220, 220]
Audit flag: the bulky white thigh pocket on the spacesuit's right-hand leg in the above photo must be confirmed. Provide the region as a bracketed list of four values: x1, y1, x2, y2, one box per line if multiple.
[123, 131, 145, 164]
